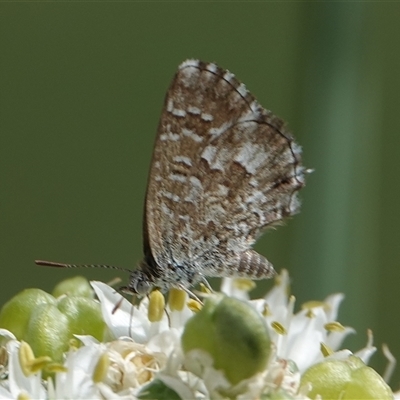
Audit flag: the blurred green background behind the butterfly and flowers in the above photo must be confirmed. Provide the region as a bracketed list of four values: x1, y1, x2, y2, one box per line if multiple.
[0, 2, 400, 388]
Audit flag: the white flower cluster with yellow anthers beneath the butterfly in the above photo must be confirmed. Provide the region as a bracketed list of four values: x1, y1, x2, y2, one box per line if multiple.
[0, 271, 384, 400]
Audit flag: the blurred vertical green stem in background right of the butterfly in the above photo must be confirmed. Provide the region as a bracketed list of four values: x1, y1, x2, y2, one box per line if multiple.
[294, 3, 380, 340]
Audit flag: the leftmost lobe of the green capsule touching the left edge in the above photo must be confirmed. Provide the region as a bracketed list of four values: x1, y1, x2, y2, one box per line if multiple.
[0, 289, 56, 340]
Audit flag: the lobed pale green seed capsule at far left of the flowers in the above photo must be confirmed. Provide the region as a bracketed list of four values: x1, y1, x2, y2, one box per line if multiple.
[0, 280, 106, 363]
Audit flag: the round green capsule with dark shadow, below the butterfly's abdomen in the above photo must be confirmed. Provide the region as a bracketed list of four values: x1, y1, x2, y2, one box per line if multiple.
[182, 296, 271, 384]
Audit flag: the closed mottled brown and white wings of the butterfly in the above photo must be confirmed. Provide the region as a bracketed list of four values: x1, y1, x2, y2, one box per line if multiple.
[144, 60, 304, 280]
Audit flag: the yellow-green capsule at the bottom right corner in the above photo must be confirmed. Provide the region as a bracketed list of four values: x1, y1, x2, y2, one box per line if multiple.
[301, 356, 393, 400]
